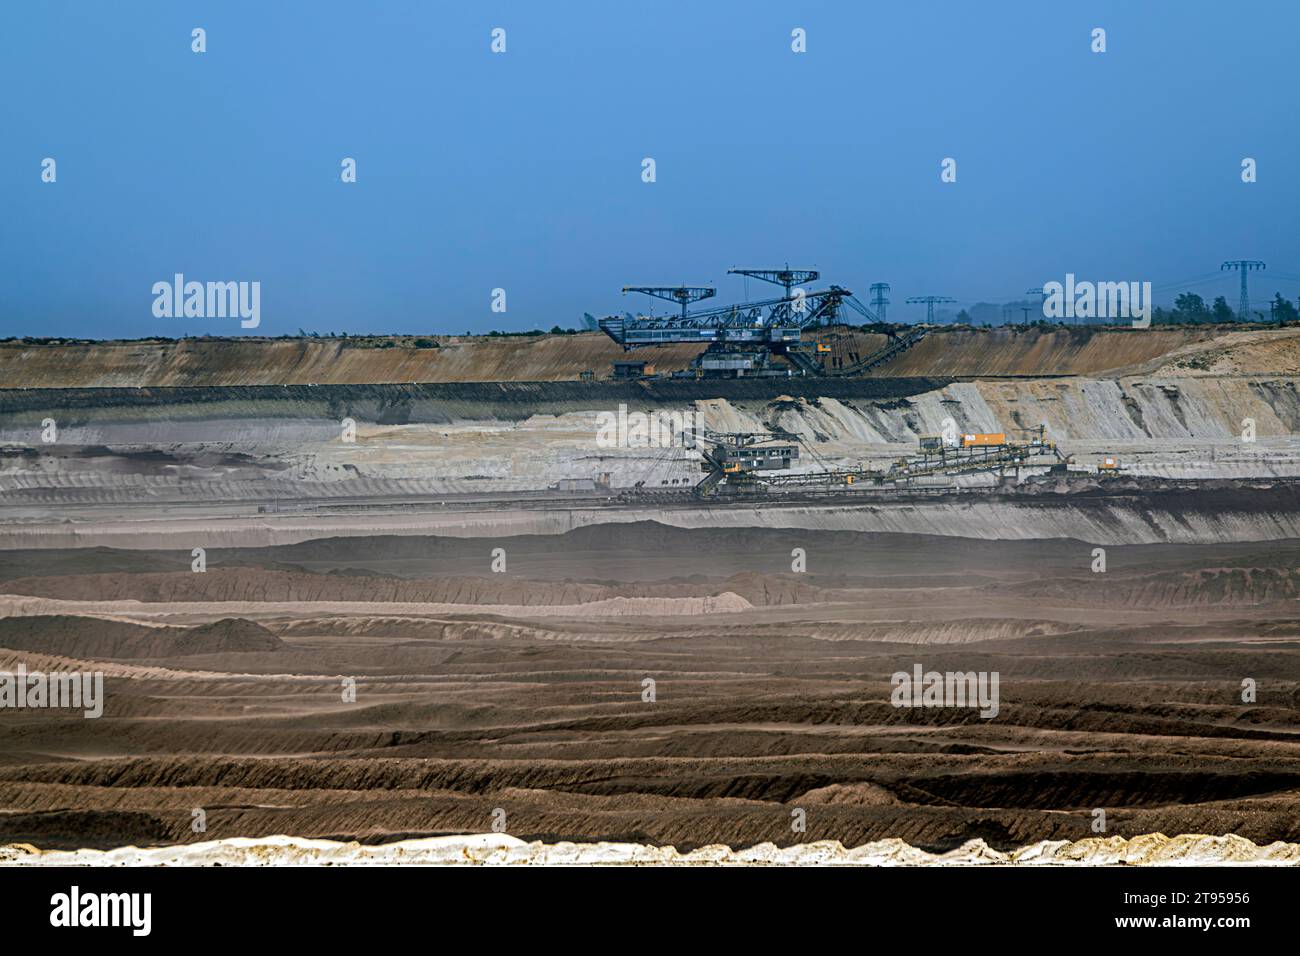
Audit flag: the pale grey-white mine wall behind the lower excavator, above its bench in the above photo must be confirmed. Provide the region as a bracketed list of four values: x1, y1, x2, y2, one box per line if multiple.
[0, 376, 1300, 498]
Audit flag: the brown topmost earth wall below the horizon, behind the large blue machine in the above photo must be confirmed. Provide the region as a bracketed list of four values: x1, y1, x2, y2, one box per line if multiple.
[0, 326, 1258, 389]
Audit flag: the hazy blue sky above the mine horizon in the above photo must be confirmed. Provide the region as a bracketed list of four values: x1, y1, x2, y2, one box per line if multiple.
[0, 0, 1300, 337]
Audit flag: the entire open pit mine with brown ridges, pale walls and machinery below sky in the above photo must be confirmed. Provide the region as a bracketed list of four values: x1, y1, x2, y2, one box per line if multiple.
[0, 323, 1300, 865]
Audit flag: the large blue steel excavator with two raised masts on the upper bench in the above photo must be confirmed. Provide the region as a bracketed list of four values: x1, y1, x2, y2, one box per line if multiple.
[598, 267, 924, 378]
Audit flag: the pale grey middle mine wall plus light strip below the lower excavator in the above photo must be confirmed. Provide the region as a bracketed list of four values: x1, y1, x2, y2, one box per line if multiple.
[0, 376, 1300, 546]
